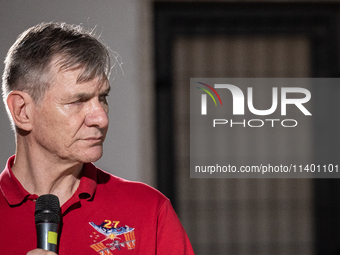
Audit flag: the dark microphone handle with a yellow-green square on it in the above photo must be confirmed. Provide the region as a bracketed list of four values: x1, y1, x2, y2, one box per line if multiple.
[35, 222, 58, 253]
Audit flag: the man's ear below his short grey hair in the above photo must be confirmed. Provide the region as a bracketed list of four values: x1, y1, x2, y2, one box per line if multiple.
[7, 90, 33, 131]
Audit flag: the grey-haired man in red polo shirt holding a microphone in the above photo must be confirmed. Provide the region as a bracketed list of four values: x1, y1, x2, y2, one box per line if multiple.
[0, 23, 193, 255]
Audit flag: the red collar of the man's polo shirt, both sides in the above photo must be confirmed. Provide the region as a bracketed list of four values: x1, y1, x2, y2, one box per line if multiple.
[0, 155, 98, 206]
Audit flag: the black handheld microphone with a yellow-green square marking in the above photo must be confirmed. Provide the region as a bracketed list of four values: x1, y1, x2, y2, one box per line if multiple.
[34, 194, 60, 253]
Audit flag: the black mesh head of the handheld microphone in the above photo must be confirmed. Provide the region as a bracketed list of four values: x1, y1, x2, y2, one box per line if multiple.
[34, 194, 60, 224]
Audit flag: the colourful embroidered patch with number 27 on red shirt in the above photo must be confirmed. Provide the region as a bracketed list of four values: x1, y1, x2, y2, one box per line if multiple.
[89, 220, 136, 255]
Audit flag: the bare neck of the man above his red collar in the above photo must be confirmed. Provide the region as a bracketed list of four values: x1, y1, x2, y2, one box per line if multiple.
[12, 137, 83, 205]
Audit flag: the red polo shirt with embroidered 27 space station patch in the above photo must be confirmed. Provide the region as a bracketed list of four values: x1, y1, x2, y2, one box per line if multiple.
[0, 156, 194, 255]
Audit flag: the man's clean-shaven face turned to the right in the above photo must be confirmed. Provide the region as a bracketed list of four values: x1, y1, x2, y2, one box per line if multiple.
[31, 63, 110, 163]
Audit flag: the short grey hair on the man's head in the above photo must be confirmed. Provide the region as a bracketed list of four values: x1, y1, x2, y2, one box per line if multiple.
[2, 22, 111, 104]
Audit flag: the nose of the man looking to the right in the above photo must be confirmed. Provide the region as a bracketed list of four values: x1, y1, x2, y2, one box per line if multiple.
[85, 99, 109, 129]
